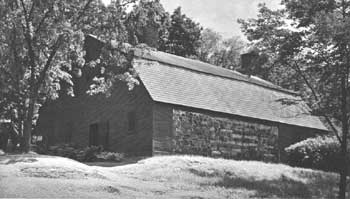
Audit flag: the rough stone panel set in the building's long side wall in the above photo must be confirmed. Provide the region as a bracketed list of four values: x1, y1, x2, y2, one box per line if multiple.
[173, 109, 279, 162]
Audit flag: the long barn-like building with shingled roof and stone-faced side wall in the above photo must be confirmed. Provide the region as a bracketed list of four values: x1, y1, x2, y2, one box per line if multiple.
[37, 34, 327, 161]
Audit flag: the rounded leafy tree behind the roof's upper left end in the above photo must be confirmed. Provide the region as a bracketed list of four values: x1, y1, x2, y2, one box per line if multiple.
[125, 0, 170, 48]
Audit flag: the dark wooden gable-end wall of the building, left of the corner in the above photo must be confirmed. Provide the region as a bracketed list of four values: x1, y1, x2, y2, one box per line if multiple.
[37, 82, 153, 155]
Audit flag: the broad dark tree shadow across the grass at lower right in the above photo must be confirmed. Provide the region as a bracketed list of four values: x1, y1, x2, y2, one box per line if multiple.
[189, 166, 342, 199]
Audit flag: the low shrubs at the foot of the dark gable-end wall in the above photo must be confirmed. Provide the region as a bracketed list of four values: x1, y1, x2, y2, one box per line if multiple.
[48, 144, 124, 162]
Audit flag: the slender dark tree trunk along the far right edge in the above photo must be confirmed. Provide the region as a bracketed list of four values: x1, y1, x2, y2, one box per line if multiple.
[339, 70, 349, 199]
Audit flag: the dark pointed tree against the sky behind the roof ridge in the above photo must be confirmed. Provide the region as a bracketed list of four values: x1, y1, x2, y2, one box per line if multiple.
[158, 7, 202, 57]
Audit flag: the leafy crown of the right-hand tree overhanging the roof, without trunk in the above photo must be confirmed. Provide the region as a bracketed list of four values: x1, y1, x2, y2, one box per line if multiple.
[239, 1, 348, 130]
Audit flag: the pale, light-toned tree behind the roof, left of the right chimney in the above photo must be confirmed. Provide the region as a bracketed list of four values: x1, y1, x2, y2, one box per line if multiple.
[197, 29, 245, 69]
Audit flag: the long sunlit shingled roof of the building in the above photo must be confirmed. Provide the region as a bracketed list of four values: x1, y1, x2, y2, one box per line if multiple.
[133, 50, 327, 130]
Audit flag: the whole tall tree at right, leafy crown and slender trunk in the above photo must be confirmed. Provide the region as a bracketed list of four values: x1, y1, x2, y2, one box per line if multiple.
[239, 0, 350, 199]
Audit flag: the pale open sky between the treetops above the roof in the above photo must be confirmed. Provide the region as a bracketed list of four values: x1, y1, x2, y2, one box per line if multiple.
[160, 0, 281, 38]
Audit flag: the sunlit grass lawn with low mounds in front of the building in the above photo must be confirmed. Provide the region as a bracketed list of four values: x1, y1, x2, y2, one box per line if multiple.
[0, 155, 348, 199]
